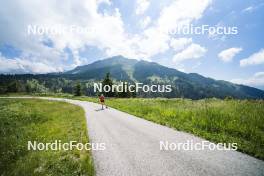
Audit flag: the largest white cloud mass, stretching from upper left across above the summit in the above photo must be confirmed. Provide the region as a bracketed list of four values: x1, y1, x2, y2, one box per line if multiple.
[0, 0, 211, 71]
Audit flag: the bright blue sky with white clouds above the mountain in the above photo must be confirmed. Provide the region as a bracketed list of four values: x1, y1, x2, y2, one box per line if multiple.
[0, 0, 264, 89]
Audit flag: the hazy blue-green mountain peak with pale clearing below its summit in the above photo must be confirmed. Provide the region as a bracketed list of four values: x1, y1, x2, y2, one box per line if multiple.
[62, 56, 264, 99]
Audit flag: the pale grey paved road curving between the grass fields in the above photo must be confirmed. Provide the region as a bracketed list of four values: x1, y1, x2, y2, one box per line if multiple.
[2, 98, 264, 176]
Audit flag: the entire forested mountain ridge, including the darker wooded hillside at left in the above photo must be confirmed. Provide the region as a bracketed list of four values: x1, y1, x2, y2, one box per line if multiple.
[0, 56, 264, 99]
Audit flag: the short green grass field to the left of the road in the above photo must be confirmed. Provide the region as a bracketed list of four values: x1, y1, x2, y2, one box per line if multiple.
[0, 99, 94, 176]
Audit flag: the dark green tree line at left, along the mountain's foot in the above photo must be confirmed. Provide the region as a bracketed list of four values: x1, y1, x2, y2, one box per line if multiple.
[0, 73, 136, 97]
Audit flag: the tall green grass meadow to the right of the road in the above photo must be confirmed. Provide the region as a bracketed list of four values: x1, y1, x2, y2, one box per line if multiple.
[75, 98, 264, 160]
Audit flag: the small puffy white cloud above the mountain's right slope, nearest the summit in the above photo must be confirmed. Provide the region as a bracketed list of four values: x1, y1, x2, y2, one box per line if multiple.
[173, 44, 207, 62]
